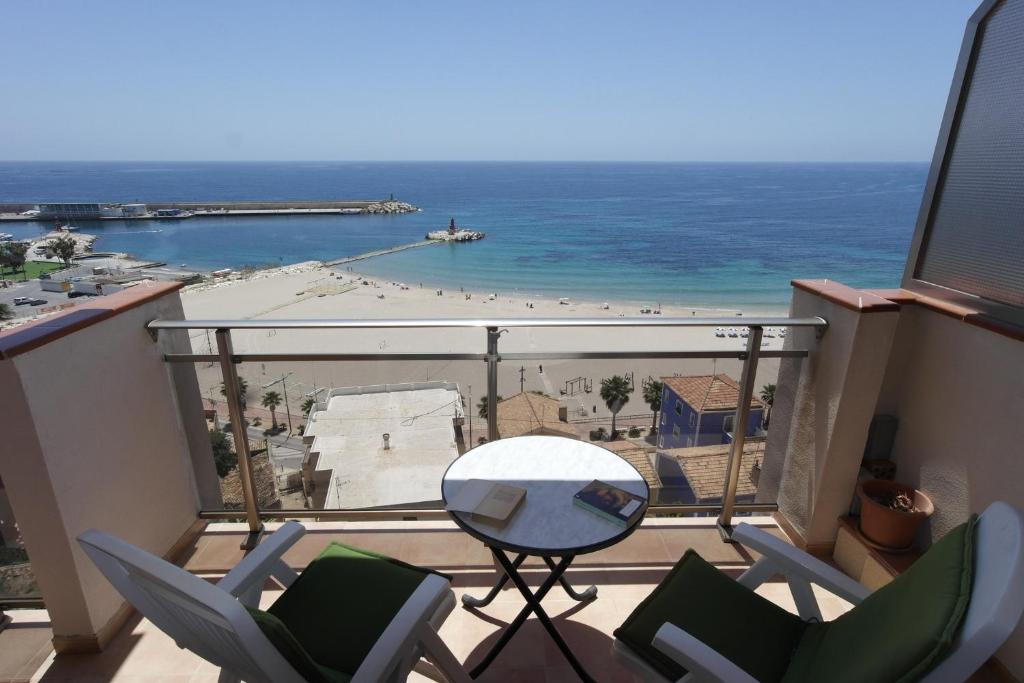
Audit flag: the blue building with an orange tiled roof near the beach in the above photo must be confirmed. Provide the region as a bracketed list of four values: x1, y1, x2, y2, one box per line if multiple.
[657, 374, 764, 449]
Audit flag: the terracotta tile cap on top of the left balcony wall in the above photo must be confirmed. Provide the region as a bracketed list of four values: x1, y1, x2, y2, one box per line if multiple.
[0, 282, 184, 359]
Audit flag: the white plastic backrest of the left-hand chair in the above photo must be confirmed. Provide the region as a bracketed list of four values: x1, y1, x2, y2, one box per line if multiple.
[78, 529, 303, 683]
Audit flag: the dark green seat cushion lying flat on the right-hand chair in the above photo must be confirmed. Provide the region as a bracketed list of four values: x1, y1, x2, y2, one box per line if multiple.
[615, 550, 806, 682]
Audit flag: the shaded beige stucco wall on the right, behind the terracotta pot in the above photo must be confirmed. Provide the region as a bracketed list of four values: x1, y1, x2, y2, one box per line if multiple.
[878, 306, 1024, 679]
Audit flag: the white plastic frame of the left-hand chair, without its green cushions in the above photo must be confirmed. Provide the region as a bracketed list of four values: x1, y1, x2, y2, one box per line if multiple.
[78, 521, 471, 683]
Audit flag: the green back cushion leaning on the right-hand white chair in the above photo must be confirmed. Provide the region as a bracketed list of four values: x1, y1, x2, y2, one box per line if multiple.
[783, 517, 977, 683]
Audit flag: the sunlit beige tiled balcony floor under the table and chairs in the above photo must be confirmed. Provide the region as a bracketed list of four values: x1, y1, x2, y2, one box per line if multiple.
[0, 518, 864, 683]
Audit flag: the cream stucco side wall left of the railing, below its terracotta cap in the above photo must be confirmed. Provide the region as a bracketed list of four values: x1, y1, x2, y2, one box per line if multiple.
[0, 293, 209, 643]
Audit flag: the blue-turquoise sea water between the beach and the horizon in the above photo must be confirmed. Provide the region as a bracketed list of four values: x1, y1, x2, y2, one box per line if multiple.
[0, 162, 928, 308]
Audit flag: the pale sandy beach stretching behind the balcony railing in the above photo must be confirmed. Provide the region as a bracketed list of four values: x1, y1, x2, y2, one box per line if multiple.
[182, 262, 785, 433]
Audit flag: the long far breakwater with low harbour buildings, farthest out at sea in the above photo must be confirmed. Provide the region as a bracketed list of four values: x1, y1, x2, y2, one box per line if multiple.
[0, 198, 419, 222]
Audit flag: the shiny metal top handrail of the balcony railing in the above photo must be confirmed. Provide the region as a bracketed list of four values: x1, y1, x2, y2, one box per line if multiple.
[146, 316, 828, 330]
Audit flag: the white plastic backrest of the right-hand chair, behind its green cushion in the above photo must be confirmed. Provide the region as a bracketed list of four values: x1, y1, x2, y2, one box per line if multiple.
[923, 502, 1024, 683]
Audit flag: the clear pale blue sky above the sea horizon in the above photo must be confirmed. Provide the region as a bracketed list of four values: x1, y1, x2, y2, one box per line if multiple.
[0, 0, 976, 161]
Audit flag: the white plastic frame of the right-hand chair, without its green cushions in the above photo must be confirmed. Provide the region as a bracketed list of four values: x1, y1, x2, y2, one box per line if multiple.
[612, 502, 1024, 683]
